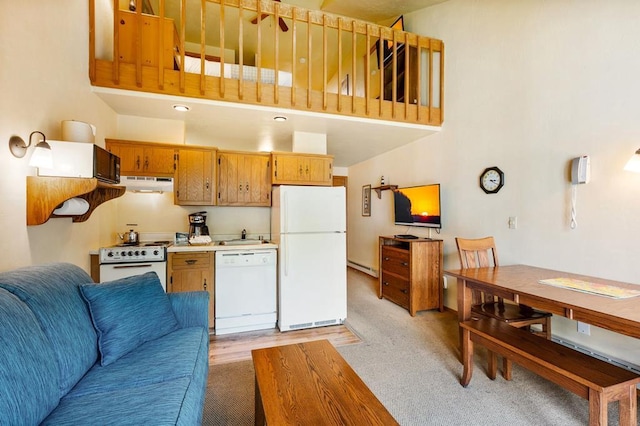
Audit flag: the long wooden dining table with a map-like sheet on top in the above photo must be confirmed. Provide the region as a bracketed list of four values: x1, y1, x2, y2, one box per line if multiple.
[444, 265, 640, 338]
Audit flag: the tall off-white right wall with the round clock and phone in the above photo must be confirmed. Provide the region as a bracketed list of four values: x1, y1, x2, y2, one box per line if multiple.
[349, 0, 640, 364]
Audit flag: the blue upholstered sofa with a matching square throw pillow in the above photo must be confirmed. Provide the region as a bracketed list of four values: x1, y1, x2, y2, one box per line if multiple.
[0, 263, 209, 425]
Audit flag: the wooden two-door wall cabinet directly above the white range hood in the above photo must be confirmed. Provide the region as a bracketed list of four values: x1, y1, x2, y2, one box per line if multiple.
[105, 139, 177, 177]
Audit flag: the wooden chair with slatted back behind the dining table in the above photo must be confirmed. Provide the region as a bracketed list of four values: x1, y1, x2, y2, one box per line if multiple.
[456, 237, 552, 380]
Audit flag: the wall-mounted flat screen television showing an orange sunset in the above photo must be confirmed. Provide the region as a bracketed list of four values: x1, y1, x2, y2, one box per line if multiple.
[393, 183, 442, 228]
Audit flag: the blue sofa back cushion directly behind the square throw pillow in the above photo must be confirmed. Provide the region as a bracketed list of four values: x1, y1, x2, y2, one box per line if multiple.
[0, 263, 98, 398]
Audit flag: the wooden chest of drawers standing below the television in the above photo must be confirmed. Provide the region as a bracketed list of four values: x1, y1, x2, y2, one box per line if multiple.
[378, 237, 444, 316]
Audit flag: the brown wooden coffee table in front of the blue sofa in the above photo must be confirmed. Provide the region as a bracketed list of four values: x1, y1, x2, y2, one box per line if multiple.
[251, 340, 398, 426]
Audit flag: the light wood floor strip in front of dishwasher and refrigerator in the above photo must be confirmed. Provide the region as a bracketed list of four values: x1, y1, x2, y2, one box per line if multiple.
[209, 325, 361, 365]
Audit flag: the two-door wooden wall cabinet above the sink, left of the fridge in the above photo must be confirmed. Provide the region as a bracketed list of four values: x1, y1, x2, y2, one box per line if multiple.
[216, 151, 271, 207]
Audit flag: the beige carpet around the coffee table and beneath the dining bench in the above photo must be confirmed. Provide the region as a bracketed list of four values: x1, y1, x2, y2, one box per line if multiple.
[203, 270, 632, 426]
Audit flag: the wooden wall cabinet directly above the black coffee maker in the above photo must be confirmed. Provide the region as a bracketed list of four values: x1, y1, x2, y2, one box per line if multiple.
[173, 148, 216, 206]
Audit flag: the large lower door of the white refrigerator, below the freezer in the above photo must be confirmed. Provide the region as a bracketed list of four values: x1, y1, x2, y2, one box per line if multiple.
[278, 233, 347, 331]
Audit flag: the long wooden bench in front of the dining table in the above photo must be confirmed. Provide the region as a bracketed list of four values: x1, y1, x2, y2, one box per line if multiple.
[460, 318, 640, 426]
